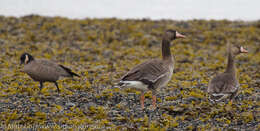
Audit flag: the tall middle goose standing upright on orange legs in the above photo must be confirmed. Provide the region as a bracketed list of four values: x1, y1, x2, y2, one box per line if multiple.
[119, 30, 185, 109]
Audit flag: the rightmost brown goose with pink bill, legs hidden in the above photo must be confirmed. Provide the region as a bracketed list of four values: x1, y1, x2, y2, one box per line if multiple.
[207, 44, 248, 102]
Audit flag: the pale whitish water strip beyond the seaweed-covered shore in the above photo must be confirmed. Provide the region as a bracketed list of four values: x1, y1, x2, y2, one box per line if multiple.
[0, 0, 260, 21]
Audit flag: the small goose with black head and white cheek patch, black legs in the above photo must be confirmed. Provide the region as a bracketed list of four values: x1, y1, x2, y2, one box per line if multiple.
[20, 53, 79, 92]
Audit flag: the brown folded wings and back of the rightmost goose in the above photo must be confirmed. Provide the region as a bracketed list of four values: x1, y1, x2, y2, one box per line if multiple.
[208, 73, 238, 93]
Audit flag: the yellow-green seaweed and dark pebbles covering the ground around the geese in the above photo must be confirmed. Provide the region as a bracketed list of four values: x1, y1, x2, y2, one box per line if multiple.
[0, 15, 260, 130]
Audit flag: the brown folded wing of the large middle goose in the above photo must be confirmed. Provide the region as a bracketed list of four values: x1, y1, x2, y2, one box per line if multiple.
[121, 59, 169, 84]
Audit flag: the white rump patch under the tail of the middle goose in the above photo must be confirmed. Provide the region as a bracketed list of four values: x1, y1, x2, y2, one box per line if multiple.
[120, 81, 148, 91]
